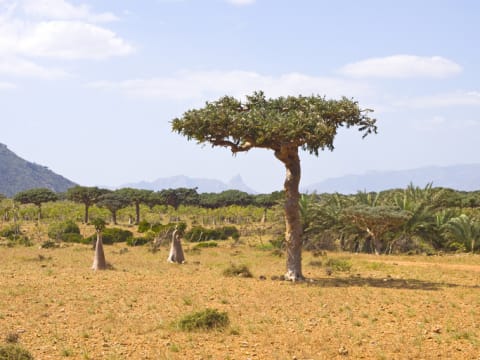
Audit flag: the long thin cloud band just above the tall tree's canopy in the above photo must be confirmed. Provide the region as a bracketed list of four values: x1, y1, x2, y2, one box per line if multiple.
[89, 71, 371, 100]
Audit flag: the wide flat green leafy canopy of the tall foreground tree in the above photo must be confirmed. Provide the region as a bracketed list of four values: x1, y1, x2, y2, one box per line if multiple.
[172, 91, 377, 155]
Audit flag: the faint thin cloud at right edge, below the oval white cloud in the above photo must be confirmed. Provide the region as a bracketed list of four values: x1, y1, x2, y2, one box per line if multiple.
[393, 91, 480, 109]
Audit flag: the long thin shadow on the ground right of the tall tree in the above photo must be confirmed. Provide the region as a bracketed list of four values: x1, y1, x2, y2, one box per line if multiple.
[307, 277, 472, 291]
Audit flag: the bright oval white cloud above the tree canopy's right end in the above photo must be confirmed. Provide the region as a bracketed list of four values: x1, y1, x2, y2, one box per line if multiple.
[340, 55, 462, 78]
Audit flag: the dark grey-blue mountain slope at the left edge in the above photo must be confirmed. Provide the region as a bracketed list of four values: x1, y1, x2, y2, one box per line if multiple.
[0, 143, 76, 197]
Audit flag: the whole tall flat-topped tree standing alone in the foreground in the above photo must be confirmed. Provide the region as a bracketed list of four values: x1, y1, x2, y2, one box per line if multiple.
[172, 91, 377, 281]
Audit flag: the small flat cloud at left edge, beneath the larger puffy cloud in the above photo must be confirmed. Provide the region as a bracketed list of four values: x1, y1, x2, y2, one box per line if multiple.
[0, 57, 68, 79]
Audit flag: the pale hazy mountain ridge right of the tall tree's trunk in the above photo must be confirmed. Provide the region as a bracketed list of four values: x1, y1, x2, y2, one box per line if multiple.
[302, 164, 480, 194]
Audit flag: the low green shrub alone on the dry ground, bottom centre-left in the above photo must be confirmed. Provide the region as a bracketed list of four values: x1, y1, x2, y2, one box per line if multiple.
[177, 309, 230, 331]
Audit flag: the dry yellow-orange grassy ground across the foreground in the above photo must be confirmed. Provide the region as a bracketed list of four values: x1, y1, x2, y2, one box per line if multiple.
[0, 242, 480, 360]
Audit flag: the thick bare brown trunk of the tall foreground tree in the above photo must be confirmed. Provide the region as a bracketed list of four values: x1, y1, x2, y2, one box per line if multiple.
[275, 146, 304, 281]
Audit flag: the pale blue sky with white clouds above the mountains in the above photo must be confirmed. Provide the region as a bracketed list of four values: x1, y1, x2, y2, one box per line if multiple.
[0, 0, 480, 193]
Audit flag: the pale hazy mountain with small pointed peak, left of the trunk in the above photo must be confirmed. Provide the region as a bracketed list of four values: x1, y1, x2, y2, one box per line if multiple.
[120, 175, 256, 194]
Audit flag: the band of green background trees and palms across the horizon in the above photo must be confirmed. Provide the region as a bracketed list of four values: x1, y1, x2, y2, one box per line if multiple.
[0, 184, 480, 254]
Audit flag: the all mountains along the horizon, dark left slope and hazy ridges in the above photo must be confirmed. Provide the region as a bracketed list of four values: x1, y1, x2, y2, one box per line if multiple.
[0, 143, 480, 197]
